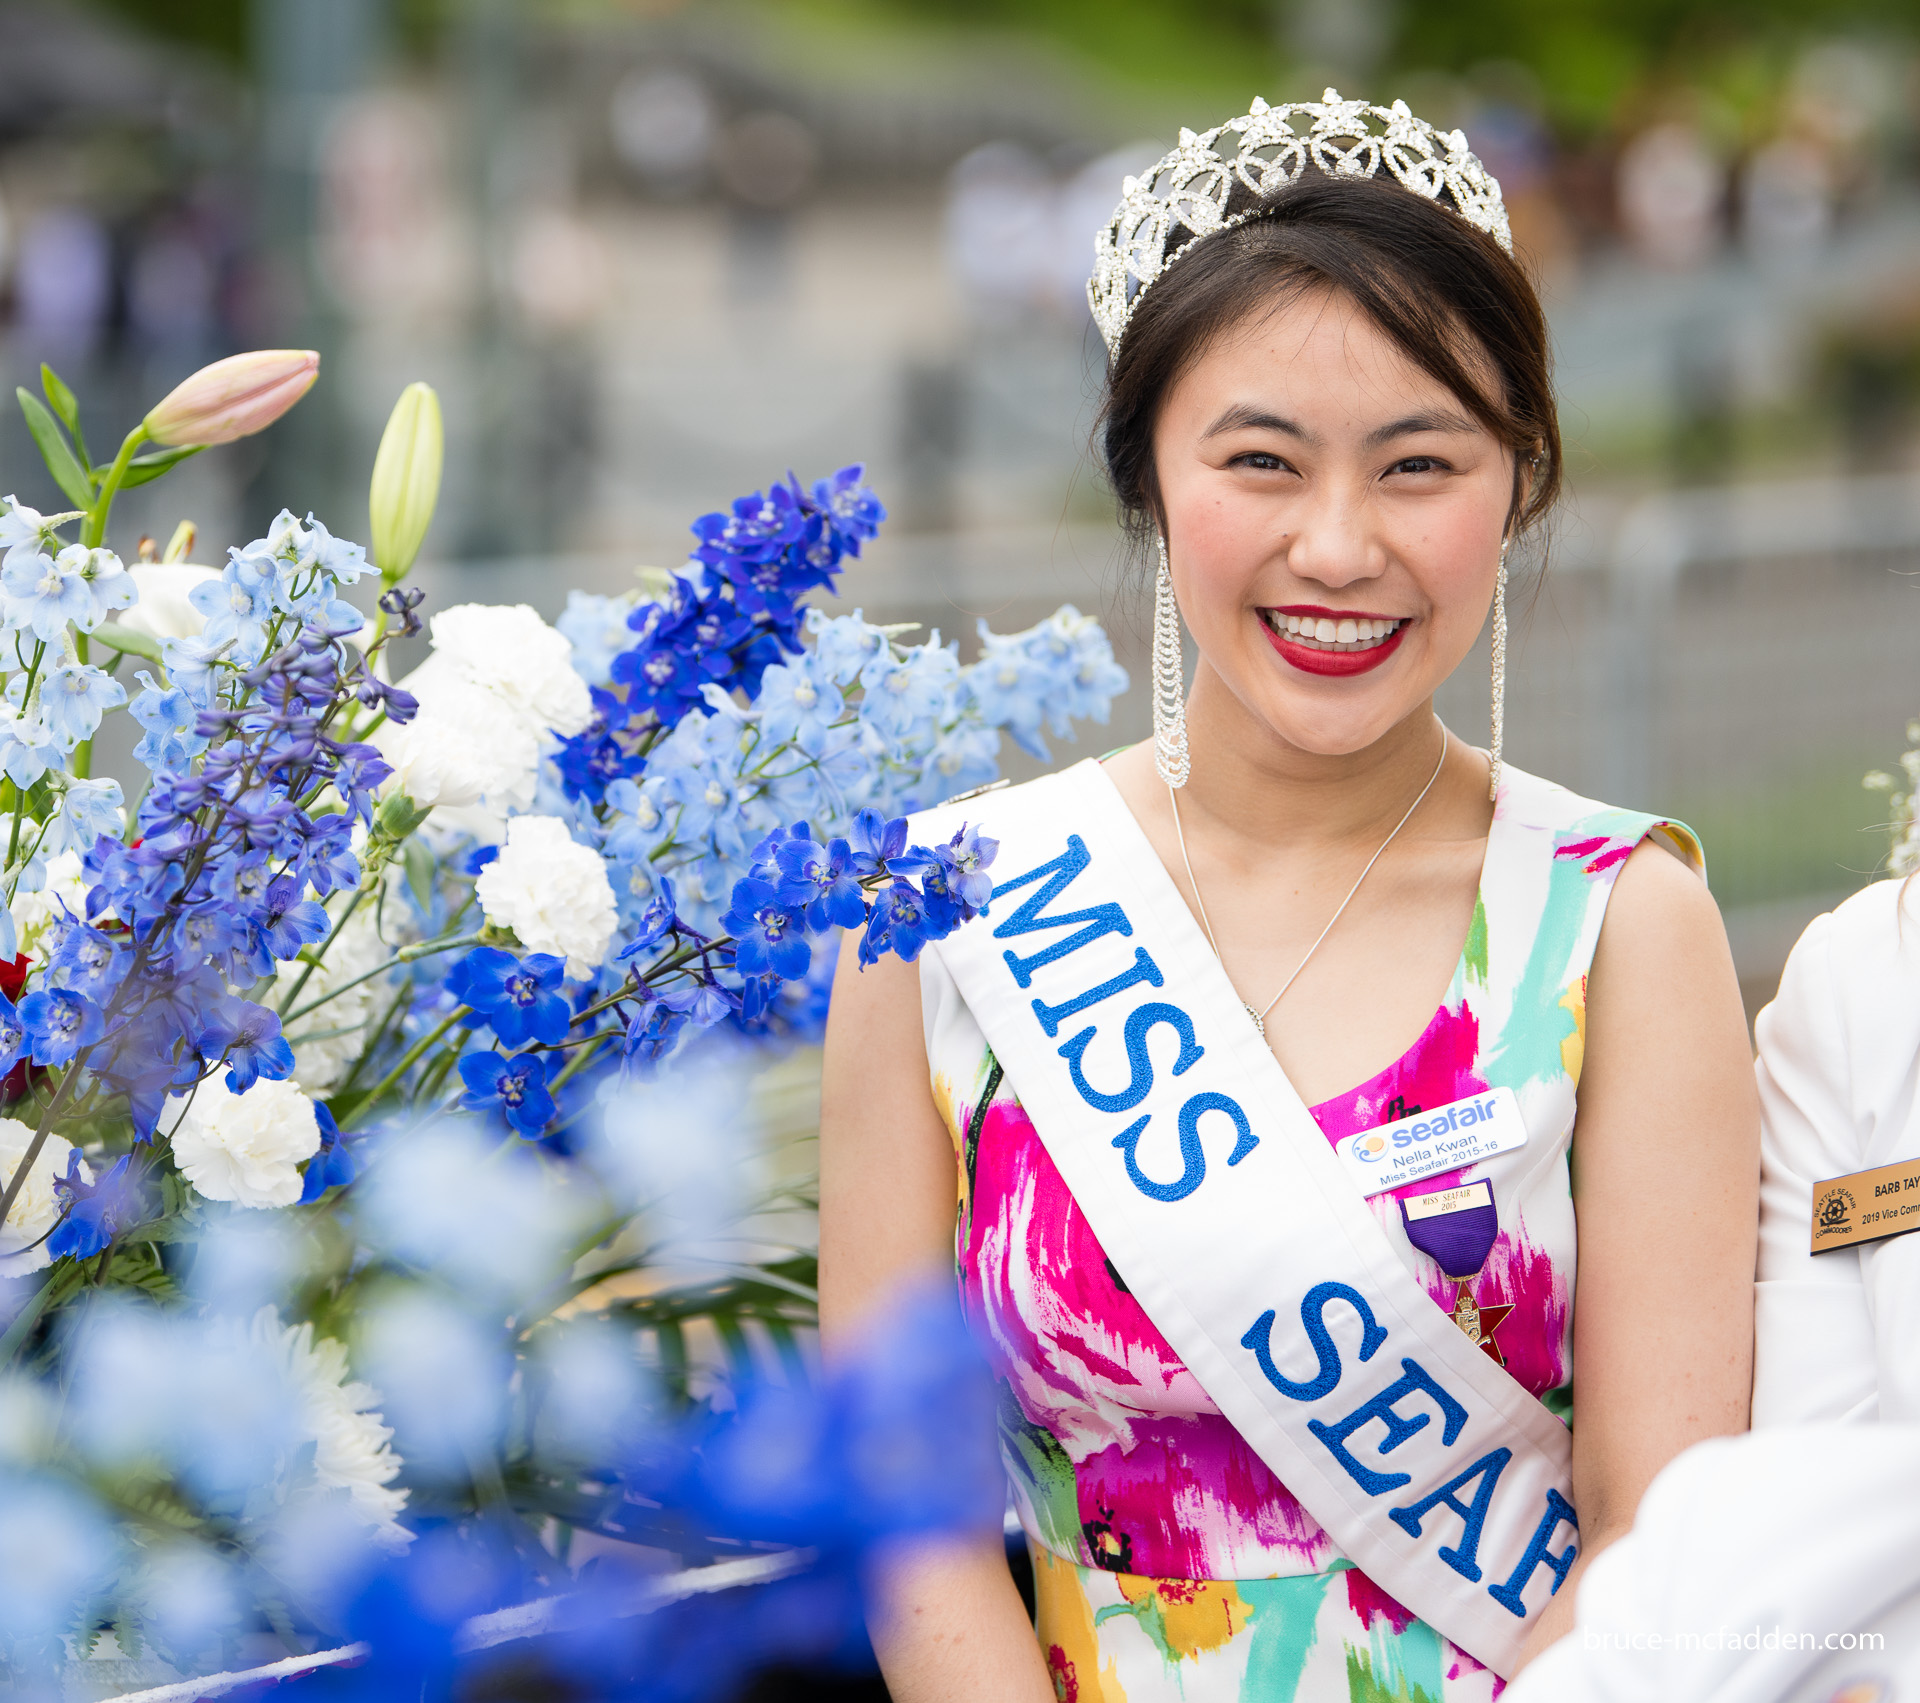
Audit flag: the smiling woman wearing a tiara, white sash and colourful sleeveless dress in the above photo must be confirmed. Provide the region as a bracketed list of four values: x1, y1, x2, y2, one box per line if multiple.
[822, 90, 1757, 1703]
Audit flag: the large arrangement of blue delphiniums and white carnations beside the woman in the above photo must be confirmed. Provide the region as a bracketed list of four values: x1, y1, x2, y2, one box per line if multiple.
[0, 357, 1125, 1699]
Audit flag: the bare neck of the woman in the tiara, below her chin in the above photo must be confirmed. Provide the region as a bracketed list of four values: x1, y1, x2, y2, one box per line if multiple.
[1181, 664, 1451, 860]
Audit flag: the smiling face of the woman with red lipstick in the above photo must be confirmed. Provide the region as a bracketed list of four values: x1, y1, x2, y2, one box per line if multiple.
[1154, 292, 1513, 756]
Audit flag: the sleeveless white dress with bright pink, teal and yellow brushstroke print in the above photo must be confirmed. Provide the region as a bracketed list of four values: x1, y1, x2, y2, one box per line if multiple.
[920, 766, 1703, 1703]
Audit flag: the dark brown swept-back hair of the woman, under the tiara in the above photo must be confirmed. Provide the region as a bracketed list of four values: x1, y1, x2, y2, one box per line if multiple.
[1094, 169, 1561, 543]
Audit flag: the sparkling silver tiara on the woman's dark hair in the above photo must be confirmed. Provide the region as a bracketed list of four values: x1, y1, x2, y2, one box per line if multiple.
[1087, 88, 1513, 355]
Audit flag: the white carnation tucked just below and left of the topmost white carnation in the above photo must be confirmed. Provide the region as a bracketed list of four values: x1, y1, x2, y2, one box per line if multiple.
[374, 655, 545, 814]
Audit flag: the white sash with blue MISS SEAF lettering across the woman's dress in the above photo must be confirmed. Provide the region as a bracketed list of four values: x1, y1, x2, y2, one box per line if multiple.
[914, 762, 1578, 1676]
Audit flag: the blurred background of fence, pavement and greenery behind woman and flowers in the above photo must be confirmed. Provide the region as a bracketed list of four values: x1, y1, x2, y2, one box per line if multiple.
[0, 0, 1920, 1010]
